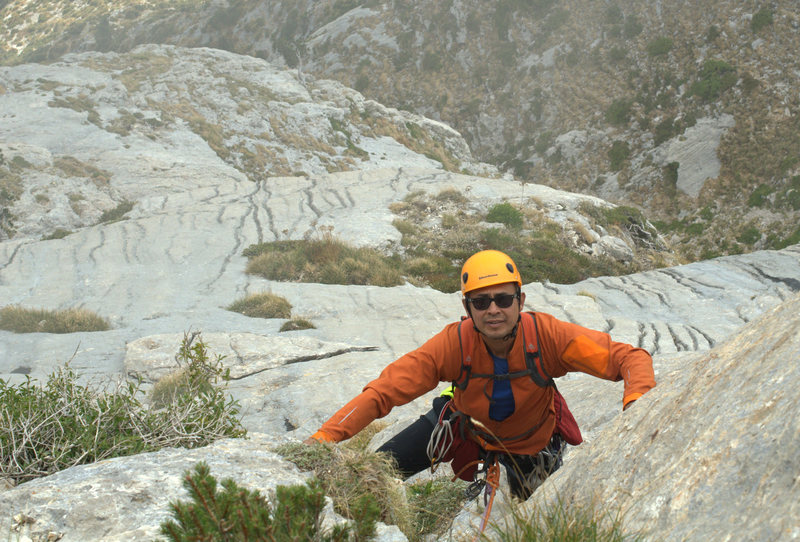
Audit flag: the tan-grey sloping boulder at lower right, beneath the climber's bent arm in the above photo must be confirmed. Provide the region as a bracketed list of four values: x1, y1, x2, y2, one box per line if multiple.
[530, 296, 800, 541]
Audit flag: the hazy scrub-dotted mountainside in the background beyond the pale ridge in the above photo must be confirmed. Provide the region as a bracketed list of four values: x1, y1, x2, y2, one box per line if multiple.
[0, 0, 800, 261]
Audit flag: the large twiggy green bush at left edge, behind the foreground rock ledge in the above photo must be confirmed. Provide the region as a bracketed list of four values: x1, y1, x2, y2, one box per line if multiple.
[0, 336, 245, 483]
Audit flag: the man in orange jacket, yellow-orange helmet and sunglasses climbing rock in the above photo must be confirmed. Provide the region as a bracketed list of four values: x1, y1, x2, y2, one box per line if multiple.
[306, 250, 656, 499]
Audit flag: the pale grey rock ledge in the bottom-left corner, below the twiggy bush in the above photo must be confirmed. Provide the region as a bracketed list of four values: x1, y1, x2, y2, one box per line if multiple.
[0, 435, 307, 542]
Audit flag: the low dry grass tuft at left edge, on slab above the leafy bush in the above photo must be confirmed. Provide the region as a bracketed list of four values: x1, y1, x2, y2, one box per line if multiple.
[0, 305, 110, 333]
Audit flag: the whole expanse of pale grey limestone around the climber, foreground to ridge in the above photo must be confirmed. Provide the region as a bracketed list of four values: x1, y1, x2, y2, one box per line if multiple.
[0, 33, 800, 541]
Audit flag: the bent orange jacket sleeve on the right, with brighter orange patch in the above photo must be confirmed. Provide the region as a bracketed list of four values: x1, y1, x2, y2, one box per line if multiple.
[536, 313, 656, 407]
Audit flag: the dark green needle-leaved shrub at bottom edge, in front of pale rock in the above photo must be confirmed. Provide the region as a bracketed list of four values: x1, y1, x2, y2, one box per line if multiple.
[161, 462, 358, 542]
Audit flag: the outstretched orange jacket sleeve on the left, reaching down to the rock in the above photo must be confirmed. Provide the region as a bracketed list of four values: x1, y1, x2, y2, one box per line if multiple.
[312, 324, 461, 442]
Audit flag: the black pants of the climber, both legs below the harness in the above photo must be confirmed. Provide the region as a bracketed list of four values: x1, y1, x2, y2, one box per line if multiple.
[378, 397, 566, 500]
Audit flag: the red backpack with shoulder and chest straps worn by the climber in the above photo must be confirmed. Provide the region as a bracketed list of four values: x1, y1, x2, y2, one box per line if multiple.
[427, 312, 583, 482]
